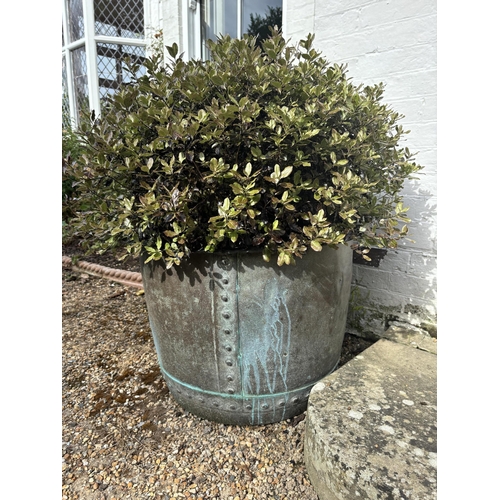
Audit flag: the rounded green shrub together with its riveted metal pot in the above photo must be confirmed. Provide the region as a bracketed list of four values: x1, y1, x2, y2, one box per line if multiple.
[72, 32, 420, 424]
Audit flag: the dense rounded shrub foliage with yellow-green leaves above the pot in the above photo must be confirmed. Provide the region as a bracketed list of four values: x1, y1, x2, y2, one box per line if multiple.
[71, 31, 421, 266]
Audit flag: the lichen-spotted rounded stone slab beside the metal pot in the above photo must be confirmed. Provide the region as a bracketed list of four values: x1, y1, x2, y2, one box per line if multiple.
[304, 339, 437, 500]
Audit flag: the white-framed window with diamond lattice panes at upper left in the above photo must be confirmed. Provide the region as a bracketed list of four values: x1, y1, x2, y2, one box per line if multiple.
[62, 0, 147, 127]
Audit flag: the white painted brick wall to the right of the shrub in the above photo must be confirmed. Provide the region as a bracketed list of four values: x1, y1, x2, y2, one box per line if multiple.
[283, 0, 437, 334]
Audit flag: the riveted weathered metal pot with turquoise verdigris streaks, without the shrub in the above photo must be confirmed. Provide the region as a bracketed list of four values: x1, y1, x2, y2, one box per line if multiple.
[142, 246, 352, 425]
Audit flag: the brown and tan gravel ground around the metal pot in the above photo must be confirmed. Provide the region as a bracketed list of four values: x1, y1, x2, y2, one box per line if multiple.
[62, 247, 370, 500]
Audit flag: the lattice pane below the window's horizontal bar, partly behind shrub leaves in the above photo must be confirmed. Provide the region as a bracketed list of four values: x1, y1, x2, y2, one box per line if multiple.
[97, 43, 146, 98]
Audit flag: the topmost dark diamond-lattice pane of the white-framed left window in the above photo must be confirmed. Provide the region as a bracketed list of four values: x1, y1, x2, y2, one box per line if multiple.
[94, 0, 144, 39]
